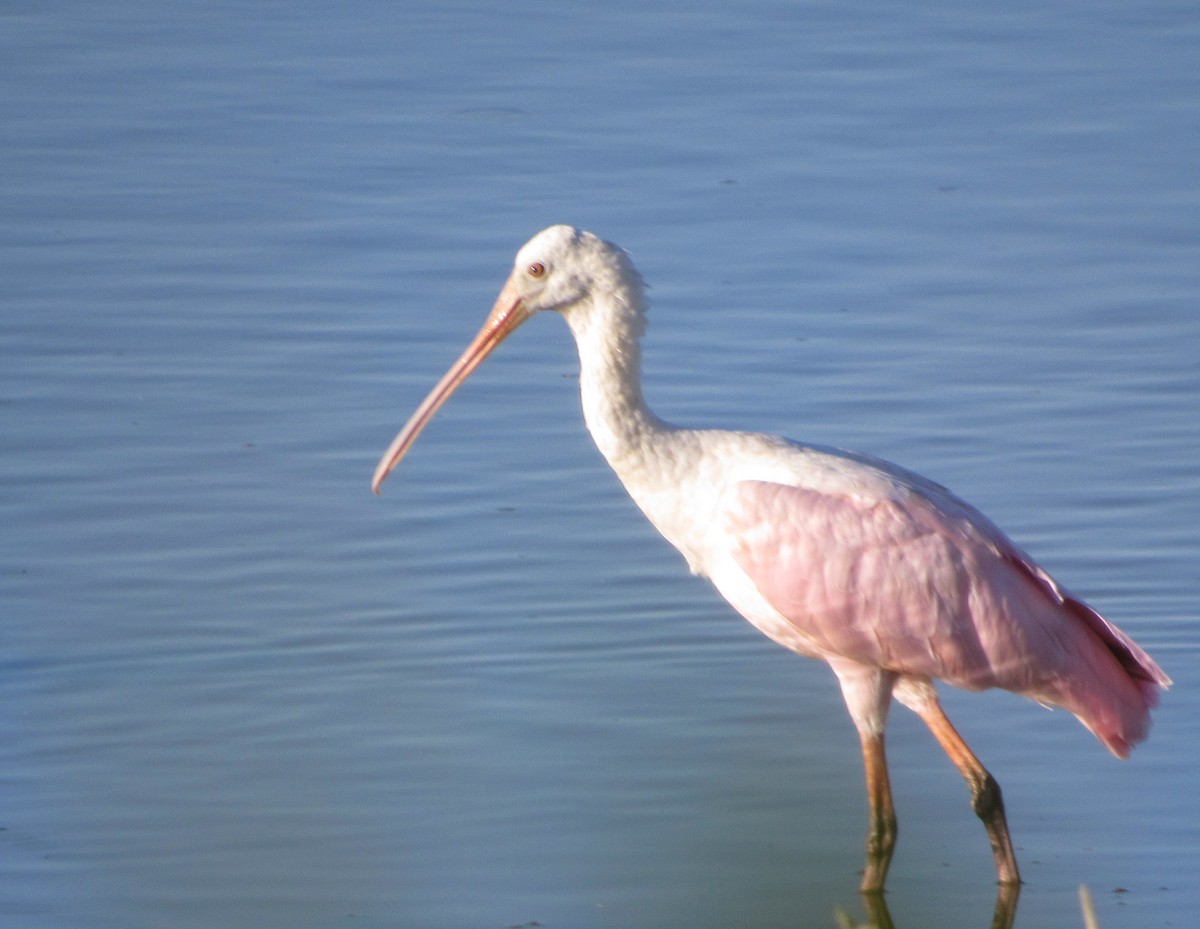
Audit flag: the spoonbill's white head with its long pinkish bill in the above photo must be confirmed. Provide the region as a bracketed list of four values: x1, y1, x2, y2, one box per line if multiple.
[371, 226, 641, 493]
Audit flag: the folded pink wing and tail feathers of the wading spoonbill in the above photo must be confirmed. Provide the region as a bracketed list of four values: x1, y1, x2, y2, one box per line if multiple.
[725, 481, 1170, 757]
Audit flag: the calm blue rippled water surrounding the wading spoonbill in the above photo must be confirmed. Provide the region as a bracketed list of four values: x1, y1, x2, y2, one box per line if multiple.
[0, 0, 1200, 929]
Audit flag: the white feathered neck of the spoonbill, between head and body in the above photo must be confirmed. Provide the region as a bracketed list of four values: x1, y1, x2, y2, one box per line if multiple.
[566, 288, 673, 472]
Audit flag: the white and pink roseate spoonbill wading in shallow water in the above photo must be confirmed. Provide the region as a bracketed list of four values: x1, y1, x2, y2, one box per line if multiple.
[371, 226, 1171, 894]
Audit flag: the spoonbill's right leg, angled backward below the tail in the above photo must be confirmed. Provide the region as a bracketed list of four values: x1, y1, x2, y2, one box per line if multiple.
[896, 678, 1021, 883]
